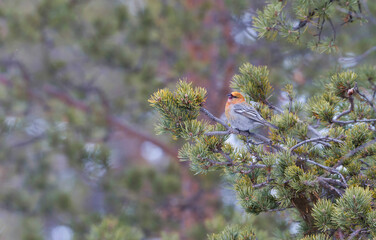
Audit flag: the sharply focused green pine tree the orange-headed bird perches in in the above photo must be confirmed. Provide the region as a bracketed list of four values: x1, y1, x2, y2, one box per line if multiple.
[149, 63, 376, 239]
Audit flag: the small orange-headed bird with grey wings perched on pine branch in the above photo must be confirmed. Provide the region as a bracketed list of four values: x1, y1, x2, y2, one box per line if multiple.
[225, 92, 278, 131]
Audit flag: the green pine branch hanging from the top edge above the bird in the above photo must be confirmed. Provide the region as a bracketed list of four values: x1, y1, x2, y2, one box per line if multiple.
[253, 0, 367, 53]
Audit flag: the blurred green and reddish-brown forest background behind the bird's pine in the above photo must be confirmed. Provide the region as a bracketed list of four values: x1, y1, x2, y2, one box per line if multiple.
[0, 0, 376, 240]
